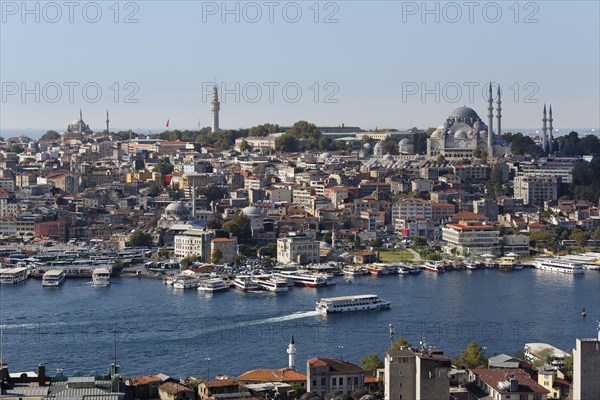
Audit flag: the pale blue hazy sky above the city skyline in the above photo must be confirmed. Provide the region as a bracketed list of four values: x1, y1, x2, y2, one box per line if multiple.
[0, 0, 600, 135]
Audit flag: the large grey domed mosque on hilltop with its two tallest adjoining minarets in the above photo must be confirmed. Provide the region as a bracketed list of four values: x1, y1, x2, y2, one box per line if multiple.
[427, 84, 508, 159]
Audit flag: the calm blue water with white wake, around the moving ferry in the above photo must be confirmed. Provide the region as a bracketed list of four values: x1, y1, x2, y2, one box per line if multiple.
[0, 269, 600, 376]
